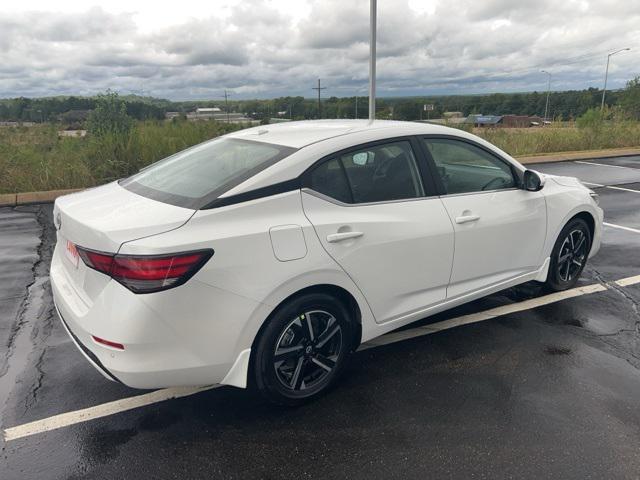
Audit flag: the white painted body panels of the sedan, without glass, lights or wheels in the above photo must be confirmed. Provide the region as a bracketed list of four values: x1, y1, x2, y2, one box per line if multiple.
[51, 121, 602, 388]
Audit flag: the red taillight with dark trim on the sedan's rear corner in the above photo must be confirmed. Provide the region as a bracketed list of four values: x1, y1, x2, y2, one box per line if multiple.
[76, 246, 213, 293]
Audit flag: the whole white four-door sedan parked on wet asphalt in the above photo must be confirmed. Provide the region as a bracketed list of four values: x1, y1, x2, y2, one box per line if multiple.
[51, 120, 603, 405]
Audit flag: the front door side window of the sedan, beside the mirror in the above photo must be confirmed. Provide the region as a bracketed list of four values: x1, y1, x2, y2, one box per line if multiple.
[423, 138, 518, 194]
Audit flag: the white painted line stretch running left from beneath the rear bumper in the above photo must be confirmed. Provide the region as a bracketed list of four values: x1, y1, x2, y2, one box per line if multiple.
[4, 385, 219, 442]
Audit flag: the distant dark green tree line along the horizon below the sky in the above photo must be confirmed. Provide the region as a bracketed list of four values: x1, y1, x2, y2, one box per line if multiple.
[0, 77, 640, 123]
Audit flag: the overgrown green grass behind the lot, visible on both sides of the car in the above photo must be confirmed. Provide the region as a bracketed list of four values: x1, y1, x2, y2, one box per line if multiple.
[0, 121, 640, 193]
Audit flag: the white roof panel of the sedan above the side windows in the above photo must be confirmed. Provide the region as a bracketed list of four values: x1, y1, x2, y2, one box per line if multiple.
[227, 120, 462, 148]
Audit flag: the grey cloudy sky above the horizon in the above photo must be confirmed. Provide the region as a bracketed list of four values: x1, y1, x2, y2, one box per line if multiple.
[0, 0, 640, 100]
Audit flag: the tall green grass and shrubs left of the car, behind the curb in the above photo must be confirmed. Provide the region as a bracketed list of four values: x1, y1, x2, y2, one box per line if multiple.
[0, 121, 239, 193]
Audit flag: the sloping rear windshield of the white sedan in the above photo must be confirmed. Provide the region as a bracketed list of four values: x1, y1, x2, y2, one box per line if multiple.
[120, 138, 296, 209]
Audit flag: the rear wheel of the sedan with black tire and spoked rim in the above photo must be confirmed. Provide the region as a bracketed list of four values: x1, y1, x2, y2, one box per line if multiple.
[253, 293, 353, 406]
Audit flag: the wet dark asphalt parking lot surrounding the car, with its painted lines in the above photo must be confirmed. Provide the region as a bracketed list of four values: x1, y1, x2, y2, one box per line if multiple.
[0, 157, 640, 480]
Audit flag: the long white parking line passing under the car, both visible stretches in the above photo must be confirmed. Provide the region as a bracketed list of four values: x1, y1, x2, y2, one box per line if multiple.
[3, 276, 640, 442]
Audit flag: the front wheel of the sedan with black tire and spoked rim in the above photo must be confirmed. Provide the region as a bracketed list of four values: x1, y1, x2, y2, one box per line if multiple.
[545, 218, 591, 292]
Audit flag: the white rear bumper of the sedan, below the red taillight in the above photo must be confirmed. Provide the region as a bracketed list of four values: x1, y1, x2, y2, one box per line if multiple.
[51, 242, 256, 389]
